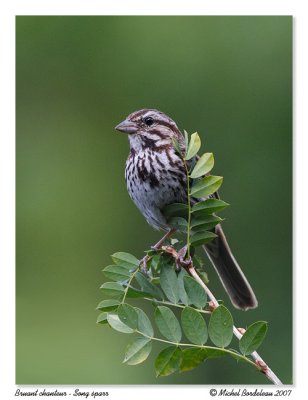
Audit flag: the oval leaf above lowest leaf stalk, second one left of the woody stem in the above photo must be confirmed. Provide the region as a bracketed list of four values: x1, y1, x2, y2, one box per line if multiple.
[181, 307, 208, 345]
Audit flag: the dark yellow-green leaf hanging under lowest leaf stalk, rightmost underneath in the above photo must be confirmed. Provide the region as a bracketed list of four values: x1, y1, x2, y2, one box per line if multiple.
[180, 348, 228, 372]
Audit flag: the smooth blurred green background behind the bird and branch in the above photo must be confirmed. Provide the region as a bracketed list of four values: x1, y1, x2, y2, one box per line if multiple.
[16, 16, 292, 384]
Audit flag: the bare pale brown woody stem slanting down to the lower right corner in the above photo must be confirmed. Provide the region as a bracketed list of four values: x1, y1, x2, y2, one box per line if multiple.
[188, 264, 282, 385]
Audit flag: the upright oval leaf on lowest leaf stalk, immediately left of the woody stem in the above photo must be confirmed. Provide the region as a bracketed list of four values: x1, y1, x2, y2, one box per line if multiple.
[209, 305, 233, 347]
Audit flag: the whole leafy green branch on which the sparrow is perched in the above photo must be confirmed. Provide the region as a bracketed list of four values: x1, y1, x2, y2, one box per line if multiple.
[98, 133, 282, 385]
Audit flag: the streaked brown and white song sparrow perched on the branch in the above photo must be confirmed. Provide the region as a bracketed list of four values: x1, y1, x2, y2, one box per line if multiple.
[116, 109, 258, 310]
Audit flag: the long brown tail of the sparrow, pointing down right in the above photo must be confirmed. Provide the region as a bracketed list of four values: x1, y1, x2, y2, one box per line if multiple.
[203, 225, 258, 310]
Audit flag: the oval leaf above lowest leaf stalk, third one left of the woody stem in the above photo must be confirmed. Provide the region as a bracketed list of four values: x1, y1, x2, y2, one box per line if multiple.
[154, 306, 182, 343]
